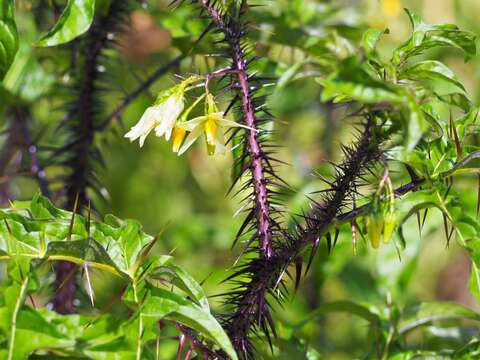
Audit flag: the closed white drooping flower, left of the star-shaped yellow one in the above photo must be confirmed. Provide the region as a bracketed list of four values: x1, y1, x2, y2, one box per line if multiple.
[125, 76, 199, 147]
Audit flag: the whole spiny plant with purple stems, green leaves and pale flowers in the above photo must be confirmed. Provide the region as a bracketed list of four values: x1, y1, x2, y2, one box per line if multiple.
[0, 0, 480, 359]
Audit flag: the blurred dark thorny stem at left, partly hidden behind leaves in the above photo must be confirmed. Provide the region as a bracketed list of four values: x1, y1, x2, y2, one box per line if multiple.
[53, 0, 126, 314]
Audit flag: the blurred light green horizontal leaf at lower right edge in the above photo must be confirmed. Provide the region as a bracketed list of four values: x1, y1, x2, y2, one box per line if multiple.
[398, 302, 480, 335]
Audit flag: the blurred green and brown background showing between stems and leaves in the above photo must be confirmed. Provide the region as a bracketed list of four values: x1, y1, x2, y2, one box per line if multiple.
[5, 0, 480, 359]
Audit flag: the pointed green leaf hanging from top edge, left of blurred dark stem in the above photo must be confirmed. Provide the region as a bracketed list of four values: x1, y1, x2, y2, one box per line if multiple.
[36, 0, 95, 46]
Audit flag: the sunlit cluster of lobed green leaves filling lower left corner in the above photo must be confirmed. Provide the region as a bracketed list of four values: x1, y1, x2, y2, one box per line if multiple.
[0, 196, 236, 359]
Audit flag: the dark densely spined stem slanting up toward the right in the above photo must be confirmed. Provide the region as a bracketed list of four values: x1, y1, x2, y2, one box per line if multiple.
[229, 123, 386, 358]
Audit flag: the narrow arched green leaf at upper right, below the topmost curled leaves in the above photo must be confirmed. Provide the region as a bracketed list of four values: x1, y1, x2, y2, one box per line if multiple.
[398, 60, 465, 91]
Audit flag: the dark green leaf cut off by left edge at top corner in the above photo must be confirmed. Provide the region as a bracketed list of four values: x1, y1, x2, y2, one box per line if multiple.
[0, 0, 18, 80]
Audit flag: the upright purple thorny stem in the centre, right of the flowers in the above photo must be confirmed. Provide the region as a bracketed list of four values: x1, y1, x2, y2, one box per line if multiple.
[200, 0, 272, 259]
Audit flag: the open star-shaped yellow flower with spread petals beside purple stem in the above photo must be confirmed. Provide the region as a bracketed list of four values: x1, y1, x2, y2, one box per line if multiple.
[177, 94, 250, 155]
